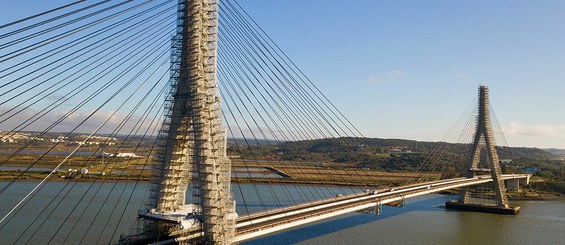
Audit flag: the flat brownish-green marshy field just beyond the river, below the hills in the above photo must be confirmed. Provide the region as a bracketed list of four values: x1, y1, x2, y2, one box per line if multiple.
[0, 154, 440, 185]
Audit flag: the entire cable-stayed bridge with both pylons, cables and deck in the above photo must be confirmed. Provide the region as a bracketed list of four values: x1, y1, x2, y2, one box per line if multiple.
[0, 0, 529, 244]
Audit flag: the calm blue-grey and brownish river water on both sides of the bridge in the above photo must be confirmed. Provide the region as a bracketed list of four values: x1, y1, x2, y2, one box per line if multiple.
[0, 182, 565, 245]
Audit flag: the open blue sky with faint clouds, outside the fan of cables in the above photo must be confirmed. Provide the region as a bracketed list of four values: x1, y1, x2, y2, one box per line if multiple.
[0, 0, 565, 149]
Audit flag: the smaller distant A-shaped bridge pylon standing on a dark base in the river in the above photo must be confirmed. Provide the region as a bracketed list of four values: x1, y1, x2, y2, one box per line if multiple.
[446, 86, 519, 214]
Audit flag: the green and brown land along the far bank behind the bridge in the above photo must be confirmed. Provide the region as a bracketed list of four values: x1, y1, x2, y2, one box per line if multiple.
[0, 138, 565, 197]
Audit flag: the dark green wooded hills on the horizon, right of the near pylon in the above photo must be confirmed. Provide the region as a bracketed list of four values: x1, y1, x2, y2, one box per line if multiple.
[228, 137, 565, 176]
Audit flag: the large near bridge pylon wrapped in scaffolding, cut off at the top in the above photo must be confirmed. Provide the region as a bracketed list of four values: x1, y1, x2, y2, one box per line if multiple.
[145, 0, 236, 244]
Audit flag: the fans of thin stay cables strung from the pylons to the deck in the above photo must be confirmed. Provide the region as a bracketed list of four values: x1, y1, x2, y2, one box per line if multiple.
[0, 0, 512, 244]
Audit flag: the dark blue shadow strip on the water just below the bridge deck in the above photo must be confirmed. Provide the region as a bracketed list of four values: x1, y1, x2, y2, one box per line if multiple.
[242, 195, 458, 245]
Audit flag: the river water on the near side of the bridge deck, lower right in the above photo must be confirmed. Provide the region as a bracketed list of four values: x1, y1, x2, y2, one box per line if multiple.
[243, 195, 565, 245]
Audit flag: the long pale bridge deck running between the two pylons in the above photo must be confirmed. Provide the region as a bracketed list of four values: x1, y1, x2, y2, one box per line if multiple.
[153, 174, 531, 242]
